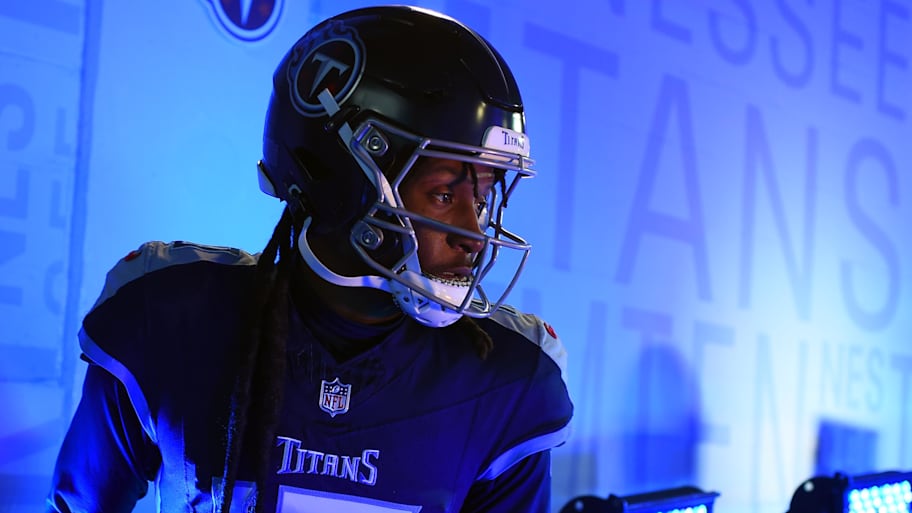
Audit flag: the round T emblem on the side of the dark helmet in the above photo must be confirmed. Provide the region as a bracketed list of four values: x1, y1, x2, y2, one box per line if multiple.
[288, 23, 364, 117]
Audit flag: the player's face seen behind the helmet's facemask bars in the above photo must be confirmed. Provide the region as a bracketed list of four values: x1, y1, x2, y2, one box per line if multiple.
[399, 158, 494, 280]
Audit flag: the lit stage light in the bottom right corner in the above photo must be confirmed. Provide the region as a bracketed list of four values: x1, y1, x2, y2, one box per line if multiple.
[788, 471, 912, 513]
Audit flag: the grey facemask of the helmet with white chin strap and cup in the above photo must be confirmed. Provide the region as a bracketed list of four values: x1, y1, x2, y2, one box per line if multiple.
[299, 113, 534, 327]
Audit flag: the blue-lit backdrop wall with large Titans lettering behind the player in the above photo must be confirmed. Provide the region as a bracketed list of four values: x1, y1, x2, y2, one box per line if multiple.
[0, 0, 912, 512]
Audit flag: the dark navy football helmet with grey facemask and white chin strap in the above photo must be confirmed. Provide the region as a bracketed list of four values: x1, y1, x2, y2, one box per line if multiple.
[259, 6, 534, 327]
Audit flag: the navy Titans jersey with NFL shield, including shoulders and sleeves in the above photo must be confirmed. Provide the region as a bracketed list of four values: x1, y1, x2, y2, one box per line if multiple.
[48, 242, 572, 513]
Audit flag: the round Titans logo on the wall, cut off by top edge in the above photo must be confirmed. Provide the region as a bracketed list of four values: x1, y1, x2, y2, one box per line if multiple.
[203, 0, 285, 41]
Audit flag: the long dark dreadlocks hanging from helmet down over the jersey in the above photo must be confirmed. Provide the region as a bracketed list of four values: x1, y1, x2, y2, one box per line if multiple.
[219, 208, 295, 513]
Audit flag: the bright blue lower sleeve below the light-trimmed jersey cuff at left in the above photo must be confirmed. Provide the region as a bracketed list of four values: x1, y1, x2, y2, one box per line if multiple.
[46, 365, 161, 513]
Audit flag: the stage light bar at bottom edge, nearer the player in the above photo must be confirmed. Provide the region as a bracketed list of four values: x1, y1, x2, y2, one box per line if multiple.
[560, 486, 719, 513]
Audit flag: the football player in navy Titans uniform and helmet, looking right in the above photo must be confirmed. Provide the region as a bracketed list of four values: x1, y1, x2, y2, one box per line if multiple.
[47, 6, 572, 513]
